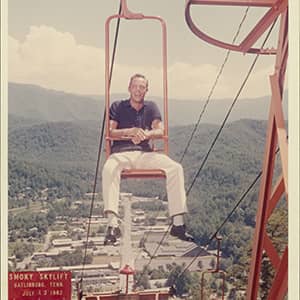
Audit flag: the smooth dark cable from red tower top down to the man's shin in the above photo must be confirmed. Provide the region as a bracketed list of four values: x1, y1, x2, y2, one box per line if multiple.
[187, 19, 277, 196]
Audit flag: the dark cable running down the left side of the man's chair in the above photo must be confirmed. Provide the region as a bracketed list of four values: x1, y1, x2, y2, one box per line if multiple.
[80, 1, 122, 289]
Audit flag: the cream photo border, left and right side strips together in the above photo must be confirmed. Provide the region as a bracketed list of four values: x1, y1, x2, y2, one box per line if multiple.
[0, 0, 300, 299]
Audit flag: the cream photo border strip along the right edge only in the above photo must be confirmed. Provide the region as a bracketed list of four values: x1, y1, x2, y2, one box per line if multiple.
[288, 0, 300, 300]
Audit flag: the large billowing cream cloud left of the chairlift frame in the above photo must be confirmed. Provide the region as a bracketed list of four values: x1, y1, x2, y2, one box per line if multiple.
[8, 26, 104, 94]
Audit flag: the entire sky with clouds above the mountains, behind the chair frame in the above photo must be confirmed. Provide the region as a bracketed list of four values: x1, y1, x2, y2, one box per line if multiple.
[8, 0, 278, 100]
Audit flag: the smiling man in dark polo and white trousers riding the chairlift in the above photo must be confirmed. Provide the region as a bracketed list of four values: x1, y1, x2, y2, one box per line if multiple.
[102, 74, 193, 244]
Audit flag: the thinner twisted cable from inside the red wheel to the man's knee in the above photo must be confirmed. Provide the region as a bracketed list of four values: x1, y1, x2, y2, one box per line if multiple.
[179, 6, 250, 163]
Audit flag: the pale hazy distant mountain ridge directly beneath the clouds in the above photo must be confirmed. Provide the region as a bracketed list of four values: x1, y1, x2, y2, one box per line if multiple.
[8, 83, 287, 126]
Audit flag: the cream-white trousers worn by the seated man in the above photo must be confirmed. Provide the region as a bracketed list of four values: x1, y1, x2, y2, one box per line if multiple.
[102, 151, 187, 216]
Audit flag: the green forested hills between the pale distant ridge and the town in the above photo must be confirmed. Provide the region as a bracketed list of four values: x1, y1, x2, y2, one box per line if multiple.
[9, 118, 265, 210]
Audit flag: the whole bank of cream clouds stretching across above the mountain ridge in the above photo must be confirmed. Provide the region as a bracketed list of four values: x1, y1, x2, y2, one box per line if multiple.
[8, 26, 272, 100]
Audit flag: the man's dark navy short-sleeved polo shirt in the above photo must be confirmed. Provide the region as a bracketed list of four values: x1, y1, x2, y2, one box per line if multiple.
[109, 99, 161, 153]
